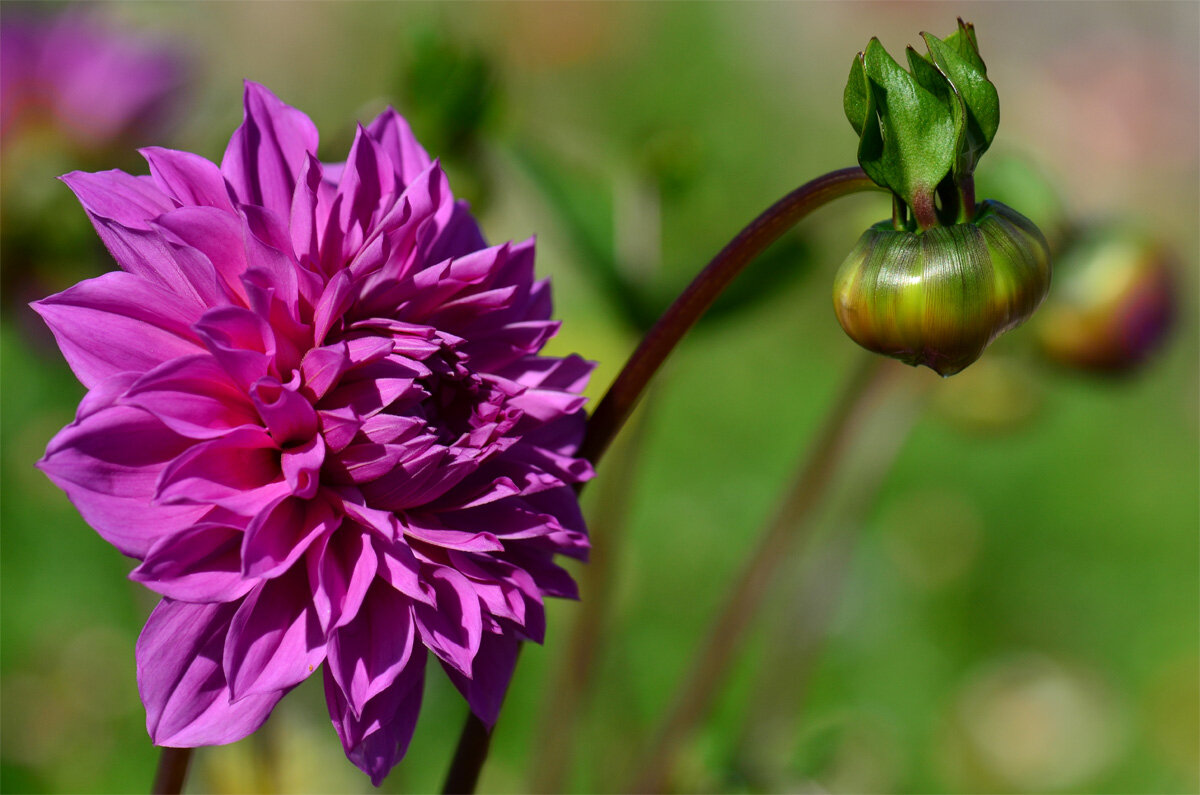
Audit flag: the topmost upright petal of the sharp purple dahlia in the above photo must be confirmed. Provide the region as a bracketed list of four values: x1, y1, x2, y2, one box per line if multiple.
[221, 80, 318, 219]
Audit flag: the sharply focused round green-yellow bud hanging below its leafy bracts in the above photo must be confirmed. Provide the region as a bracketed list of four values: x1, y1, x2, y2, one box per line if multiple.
[833, 201, 1050, 376]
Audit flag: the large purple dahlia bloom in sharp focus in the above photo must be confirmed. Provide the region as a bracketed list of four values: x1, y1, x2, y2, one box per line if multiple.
[35, 83, 592, 784]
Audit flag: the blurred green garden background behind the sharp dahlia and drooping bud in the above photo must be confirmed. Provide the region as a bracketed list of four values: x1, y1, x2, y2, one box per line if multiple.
[0, 2, 1200, 793]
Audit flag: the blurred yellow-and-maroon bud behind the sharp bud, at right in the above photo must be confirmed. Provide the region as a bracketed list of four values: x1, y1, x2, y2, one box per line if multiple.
[1037, 226, 1177, 372]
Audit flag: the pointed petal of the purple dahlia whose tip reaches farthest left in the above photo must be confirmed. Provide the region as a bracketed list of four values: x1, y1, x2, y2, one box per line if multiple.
[32, 271, 203, 389]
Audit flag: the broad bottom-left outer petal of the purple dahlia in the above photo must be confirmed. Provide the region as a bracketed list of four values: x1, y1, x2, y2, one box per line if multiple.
[137, 599, 286, 748]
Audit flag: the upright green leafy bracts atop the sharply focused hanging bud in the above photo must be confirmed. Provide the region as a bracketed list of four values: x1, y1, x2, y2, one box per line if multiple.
[844, 19, 1000, 229]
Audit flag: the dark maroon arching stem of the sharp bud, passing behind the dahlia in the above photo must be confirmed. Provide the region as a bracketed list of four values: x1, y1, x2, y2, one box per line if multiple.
[442, 166, 880, 794]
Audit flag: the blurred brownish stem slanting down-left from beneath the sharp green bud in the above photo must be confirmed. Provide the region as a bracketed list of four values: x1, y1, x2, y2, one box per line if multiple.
[629, 357, 889, 793]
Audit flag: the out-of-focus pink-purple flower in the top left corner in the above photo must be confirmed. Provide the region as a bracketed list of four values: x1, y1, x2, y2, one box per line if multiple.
[0, 12, 184, 149]
